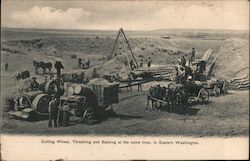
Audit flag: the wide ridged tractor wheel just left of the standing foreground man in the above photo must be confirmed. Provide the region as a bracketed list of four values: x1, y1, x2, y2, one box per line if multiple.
[32, 94, 51, 115]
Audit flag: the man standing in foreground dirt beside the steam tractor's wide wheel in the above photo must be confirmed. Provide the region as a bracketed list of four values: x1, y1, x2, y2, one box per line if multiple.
[48, 96, 58, 127]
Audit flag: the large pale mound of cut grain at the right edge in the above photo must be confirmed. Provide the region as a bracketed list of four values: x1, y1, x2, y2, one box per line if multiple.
[214, 38, 249, 89]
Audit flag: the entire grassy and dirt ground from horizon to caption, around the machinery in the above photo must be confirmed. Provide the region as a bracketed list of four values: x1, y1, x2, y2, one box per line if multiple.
[1, 29, 249, 137]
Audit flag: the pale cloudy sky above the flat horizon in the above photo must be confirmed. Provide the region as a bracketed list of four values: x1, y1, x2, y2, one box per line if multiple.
[1, 0, 249, 30]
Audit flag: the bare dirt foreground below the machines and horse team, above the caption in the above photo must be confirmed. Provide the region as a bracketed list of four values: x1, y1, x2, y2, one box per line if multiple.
[3, 89, 249, 137]
